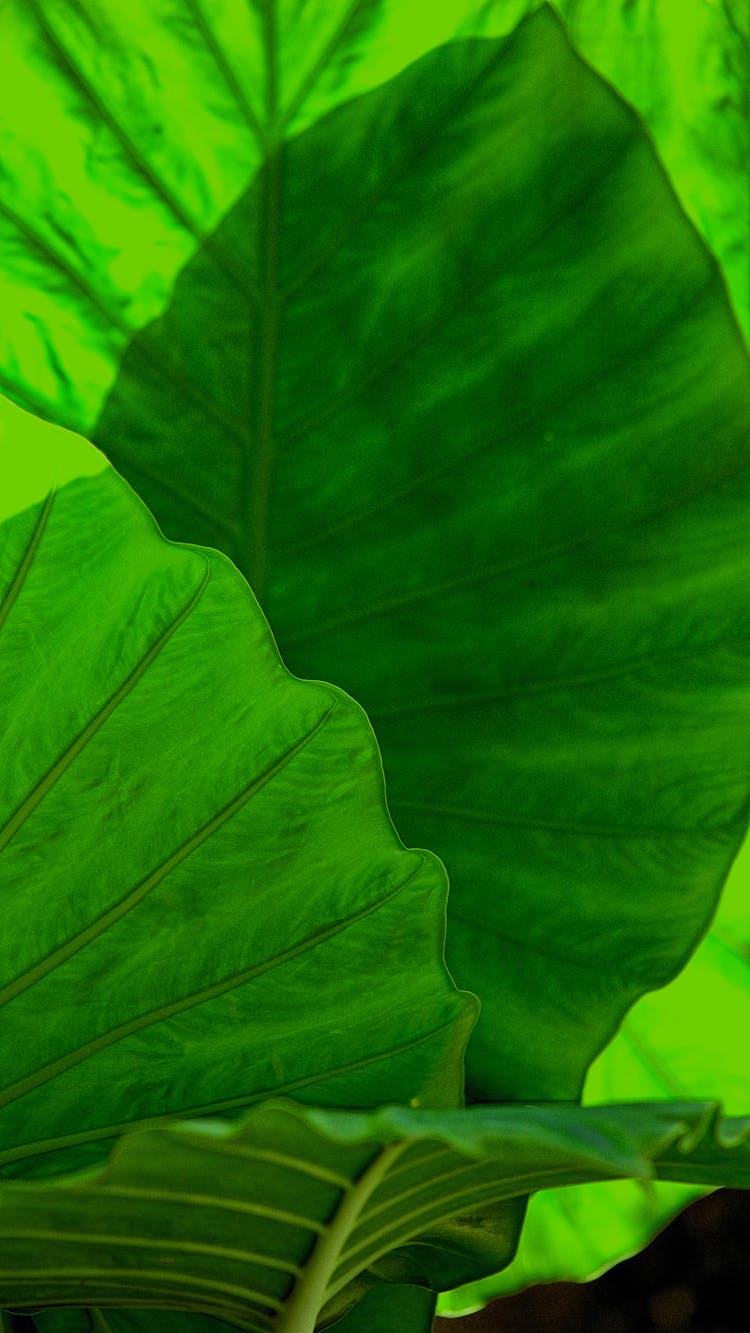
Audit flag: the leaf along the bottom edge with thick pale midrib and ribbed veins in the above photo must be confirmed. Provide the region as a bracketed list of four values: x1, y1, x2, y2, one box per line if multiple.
[0, 1100, 750, 1333]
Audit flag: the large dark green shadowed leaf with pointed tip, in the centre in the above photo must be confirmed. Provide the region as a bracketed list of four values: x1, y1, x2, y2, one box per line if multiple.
[52, 2, 750, 1100]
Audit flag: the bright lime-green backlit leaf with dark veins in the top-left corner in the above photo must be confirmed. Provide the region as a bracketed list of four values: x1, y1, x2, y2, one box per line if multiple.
[0, 0, 526, 433]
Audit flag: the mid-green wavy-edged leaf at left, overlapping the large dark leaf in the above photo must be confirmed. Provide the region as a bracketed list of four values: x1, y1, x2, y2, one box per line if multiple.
[0, 391, 476, 1177]
